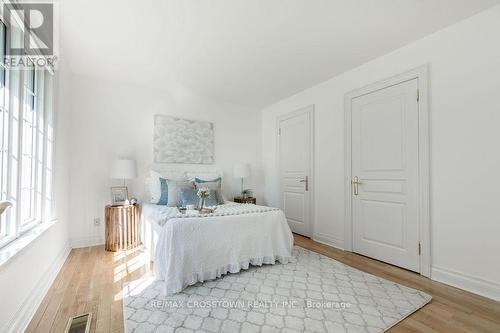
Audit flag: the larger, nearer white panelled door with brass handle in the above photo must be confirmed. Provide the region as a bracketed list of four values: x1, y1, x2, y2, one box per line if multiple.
[351, 79, 420, 272]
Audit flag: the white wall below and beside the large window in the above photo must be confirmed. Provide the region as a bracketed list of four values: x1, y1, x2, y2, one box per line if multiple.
[0, 68, 70, 332]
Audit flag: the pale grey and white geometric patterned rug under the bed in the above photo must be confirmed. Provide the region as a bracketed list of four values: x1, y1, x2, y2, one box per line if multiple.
[123, 246, 431, 333]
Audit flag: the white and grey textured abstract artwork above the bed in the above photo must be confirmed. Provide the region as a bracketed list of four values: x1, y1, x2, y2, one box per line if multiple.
[153, 115, 214, 164]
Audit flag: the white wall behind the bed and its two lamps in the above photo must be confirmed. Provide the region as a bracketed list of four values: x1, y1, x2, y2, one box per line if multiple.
[66, 75, 263, 246]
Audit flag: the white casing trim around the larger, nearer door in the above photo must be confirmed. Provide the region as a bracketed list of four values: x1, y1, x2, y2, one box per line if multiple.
[344, 64, 431, 277]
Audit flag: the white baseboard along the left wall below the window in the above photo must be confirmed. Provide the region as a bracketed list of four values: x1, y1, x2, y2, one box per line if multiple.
[6, 243, 71, 333]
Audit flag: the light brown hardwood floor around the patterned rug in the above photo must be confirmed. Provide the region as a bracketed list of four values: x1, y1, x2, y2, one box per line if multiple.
[27, 235, 500, 333]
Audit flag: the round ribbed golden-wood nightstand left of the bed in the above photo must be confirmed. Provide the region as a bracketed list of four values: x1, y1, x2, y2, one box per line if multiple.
[105, 205, 141, 252]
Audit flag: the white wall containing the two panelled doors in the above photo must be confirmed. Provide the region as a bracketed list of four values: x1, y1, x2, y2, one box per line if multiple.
[262, 6, 500, 299]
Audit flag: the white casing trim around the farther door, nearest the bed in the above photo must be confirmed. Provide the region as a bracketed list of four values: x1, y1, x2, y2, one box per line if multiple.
[276, 104, 315, 237]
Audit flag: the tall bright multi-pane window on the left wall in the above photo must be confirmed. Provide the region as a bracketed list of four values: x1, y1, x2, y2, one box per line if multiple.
[0, 21, 54, 247]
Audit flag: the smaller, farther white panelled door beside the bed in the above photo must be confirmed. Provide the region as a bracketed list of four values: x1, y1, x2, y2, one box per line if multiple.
[278, 107, 312, 237]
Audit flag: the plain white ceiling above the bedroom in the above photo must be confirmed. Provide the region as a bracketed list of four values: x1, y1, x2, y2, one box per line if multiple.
[61, 0, 500, 106]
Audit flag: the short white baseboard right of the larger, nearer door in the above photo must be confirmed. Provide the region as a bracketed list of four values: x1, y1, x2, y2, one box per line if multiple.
[431, 266, 500, 301]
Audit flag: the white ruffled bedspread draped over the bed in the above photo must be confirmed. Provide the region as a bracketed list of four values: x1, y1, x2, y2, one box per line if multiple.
[143, 204, 293, 294]
